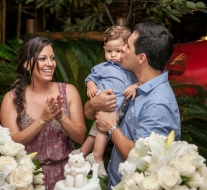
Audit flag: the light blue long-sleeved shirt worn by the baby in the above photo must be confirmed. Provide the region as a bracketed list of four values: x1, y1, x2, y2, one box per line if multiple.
[85, 61, 137, 110]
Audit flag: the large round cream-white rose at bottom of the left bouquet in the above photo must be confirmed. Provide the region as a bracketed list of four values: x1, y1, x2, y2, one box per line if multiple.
[7, 165, 33, 188]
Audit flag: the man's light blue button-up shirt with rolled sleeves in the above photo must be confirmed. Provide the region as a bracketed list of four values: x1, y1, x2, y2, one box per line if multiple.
[108, 72, 181, 190]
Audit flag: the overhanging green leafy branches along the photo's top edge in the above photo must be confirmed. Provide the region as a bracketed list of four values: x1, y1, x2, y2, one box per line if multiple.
[16, 0, 207, 31]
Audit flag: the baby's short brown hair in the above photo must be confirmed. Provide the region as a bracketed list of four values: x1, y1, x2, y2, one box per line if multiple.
[104, 26, 131, 44]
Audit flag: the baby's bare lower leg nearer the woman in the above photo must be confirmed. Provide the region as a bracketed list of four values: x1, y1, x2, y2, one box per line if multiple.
[80, 135, 95, 157]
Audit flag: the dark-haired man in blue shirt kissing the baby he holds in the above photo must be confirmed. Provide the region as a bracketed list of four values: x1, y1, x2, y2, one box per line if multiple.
[85, 22, 180, 189]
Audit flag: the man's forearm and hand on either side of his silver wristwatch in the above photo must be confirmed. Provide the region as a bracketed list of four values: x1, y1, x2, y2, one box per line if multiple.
[96, 111, 134, 160]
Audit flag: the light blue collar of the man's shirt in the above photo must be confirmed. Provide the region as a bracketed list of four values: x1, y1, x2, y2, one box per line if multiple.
[138, 71, 168, 93]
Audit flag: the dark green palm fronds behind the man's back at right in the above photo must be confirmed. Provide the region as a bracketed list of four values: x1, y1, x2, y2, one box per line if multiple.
[171, 81, 207, 159]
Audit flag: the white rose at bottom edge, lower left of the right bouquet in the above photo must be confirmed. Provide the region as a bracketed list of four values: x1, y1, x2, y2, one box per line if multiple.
[141, 173, 161, 190]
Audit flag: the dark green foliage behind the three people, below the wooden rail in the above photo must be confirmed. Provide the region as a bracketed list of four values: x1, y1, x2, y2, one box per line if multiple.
[0, 39, 207, 167]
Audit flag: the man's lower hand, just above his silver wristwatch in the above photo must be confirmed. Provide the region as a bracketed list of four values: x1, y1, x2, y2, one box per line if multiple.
[95, 111, 117, 132]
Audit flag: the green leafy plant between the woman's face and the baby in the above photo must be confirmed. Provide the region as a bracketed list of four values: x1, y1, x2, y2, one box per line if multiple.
[54, 39, 105, 128]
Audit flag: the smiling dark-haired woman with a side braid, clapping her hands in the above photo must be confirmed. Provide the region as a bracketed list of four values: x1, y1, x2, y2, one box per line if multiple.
[1, 37, 87, 190]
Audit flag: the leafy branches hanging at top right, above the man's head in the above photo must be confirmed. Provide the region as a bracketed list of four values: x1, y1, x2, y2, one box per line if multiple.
[100, 0, 207, 25]
